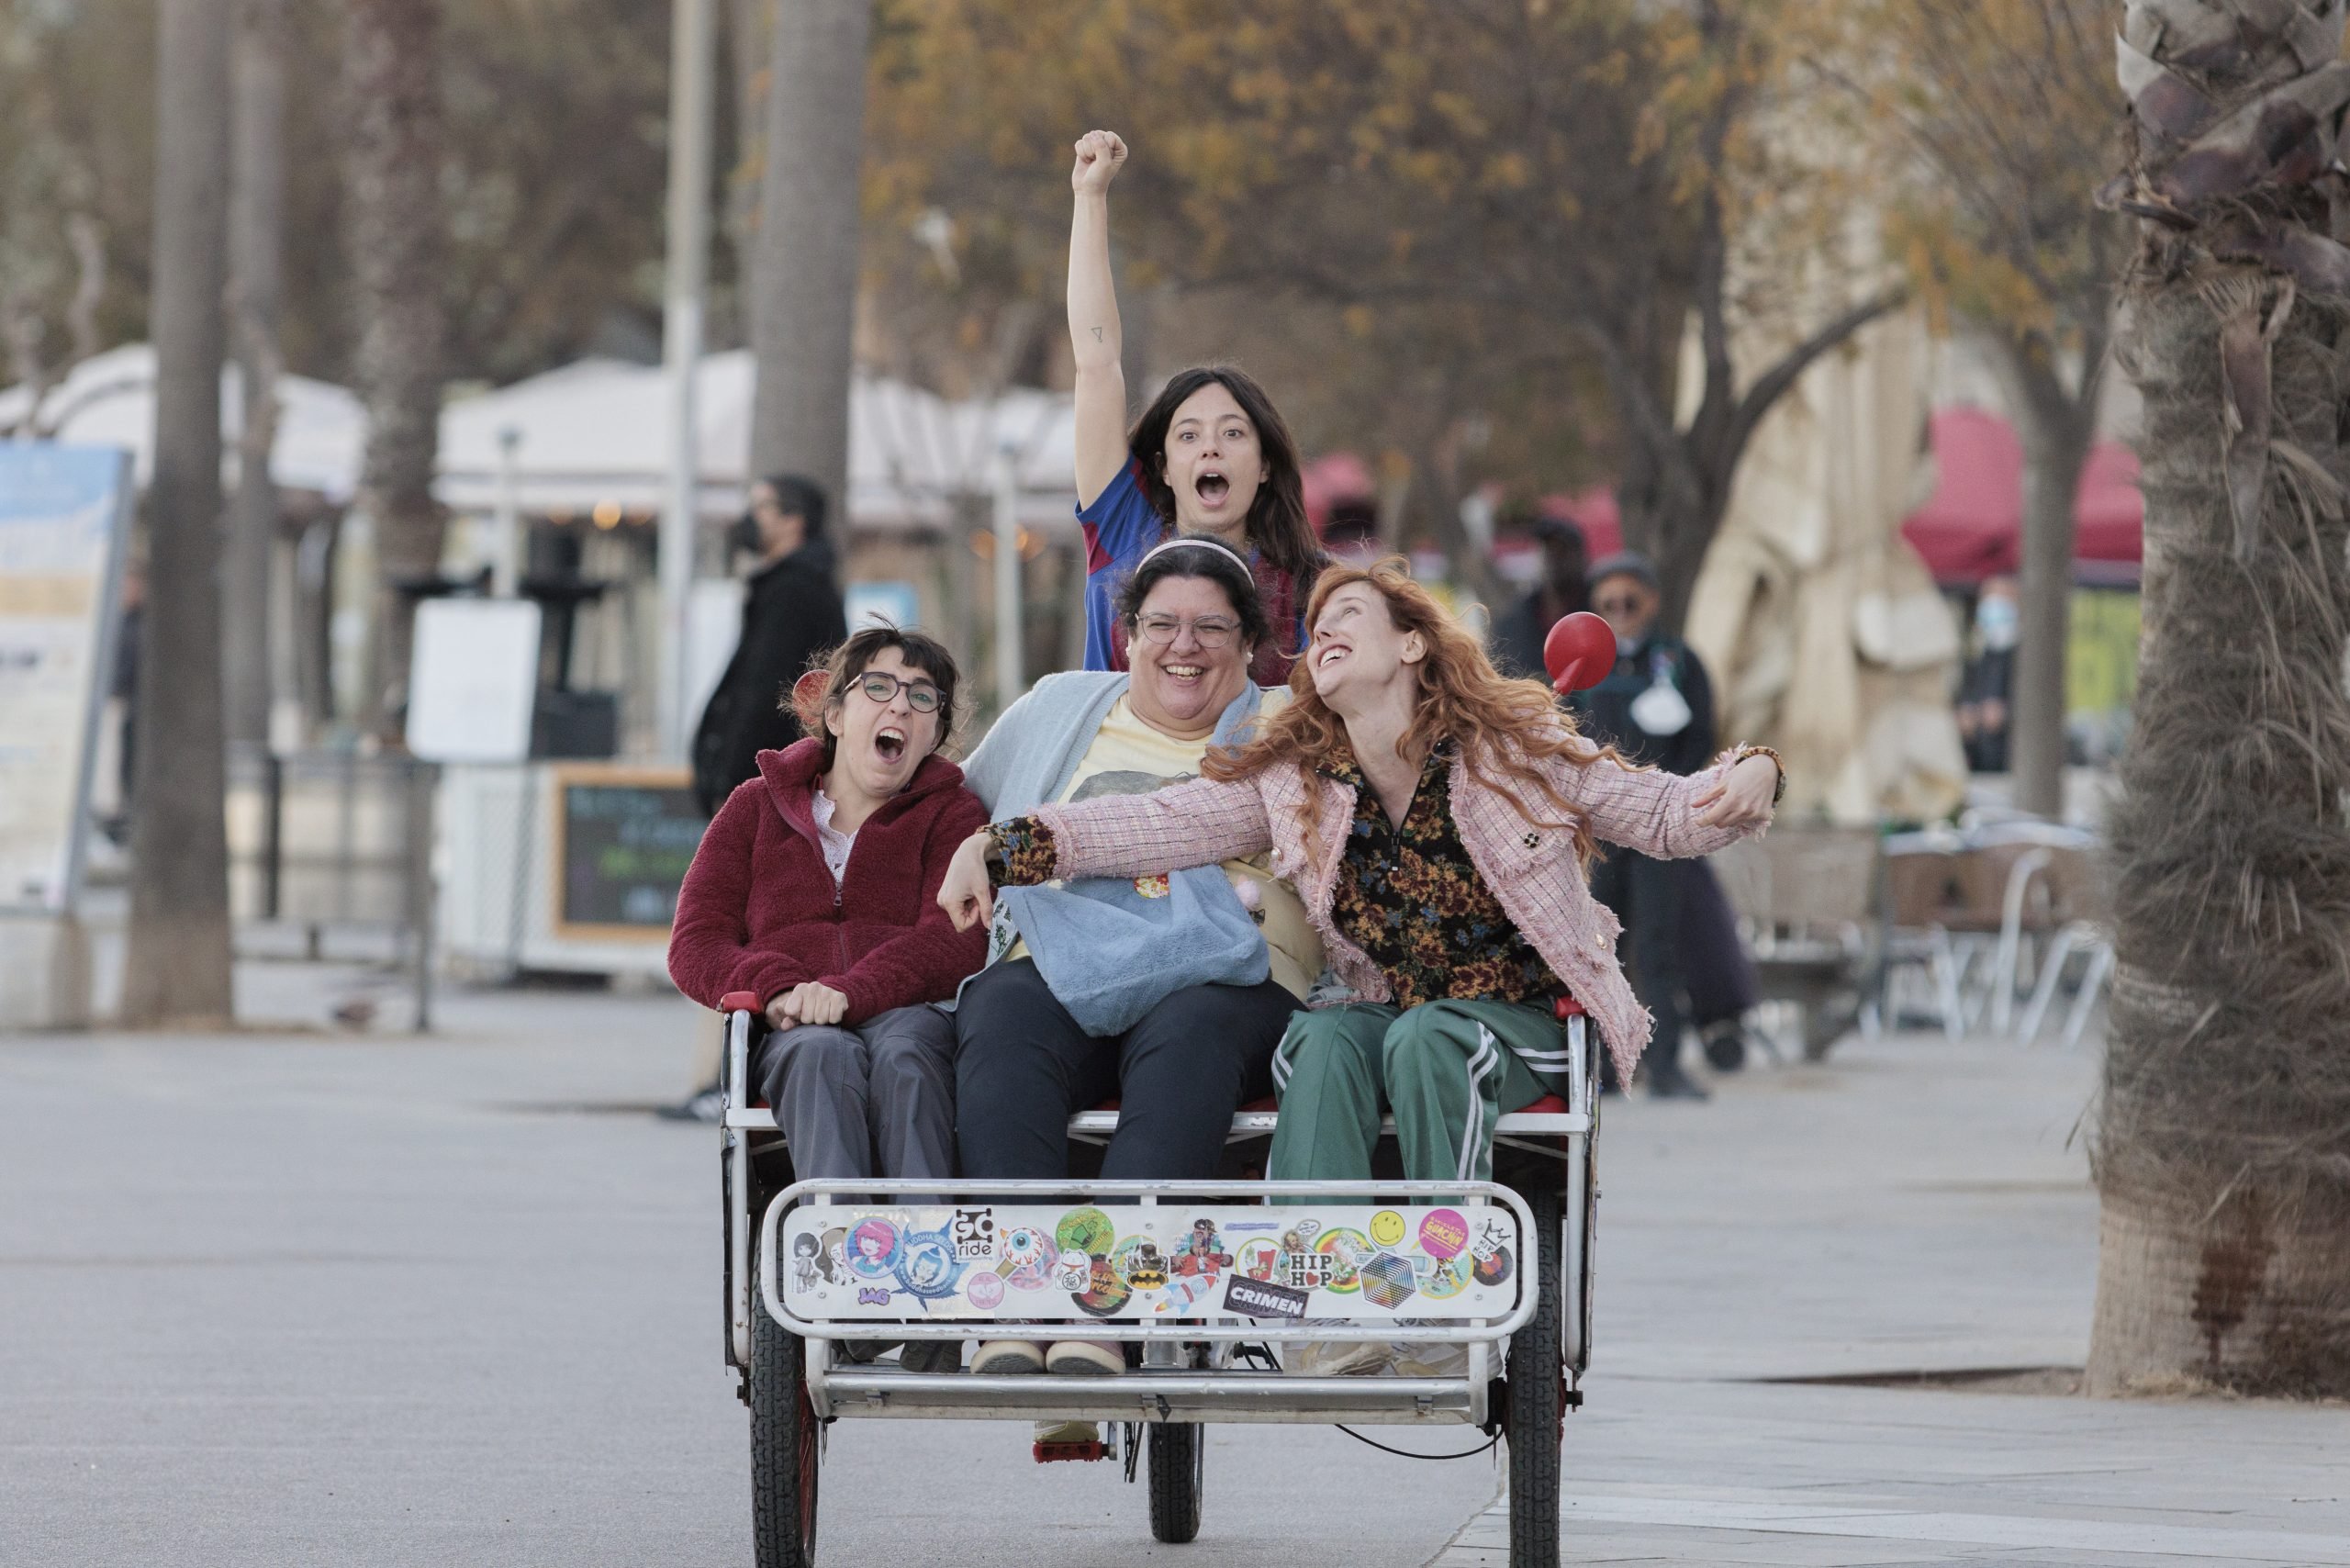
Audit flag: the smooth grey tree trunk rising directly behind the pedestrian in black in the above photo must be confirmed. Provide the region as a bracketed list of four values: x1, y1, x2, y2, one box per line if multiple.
[750, 0, 872, 514]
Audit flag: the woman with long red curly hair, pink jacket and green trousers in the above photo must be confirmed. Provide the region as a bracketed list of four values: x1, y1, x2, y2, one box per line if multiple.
[937, 559, 1781, 1180]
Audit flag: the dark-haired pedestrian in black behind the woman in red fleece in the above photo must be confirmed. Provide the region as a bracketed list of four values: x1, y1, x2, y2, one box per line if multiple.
[693, 475, 848, 816]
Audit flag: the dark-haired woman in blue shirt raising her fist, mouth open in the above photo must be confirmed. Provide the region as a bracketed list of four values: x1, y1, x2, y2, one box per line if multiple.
[1069, 131, 1327, 687]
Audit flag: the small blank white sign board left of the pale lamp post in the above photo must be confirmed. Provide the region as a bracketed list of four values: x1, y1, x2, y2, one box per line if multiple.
[408, 599, 538, 762]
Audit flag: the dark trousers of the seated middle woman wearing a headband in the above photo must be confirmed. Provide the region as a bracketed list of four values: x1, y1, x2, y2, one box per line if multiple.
[954, 959, 1297, 1180]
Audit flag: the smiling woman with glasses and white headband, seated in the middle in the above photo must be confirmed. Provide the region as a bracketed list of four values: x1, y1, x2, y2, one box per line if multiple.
[954, 536, 1323, 1401]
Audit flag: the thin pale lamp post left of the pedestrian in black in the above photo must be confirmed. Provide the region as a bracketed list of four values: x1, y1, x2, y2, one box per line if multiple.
[654, 0, 712, 757]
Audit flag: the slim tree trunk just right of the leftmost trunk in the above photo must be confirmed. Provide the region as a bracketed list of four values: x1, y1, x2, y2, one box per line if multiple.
[221, 0, 286, 745]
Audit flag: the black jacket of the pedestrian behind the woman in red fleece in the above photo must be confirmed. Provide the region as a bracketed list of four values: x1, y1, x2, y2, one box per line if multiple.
[693, 538, 848, 813]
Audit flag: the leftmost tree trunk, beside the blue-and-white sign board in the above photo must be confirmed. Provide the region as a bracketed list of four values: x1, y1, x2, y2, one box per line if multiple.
[122, 0, 235, 1025]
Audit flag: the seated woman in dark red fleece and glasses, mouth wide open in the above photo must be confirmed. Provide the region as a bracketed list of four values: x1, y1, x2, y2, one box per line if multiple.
[670, 628, 987, 1368]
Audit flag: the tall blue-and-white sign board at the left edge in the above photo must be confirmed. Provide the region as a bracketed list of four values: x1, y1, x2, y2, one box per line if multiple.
[0, 442, 129, 913]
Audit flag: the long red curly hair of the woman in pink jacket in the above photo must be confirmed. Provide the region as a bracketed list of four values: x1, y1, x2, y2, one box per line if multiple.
[1201, 554, 1628, 872]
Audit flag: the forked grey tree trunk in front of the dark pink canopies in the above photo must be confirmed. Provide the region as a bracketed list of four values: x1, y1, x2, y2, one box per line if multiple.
[1988, 334, 2098, 821]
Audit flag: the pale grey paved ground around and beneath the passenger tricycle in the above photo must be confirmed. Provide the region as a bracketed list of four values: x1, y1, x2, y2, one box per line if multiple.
[0, 966, 2350, 1568]
